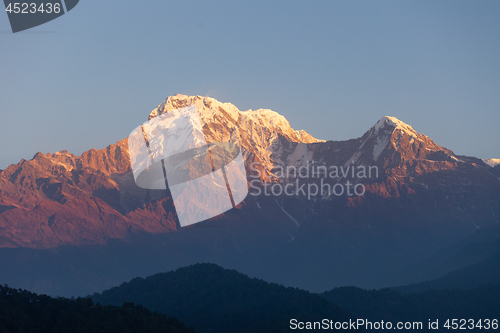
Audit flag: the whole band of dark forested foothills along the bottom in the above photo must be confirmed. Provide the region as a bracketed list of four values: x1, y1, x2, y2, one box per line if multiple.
[0, 264, 500, 333]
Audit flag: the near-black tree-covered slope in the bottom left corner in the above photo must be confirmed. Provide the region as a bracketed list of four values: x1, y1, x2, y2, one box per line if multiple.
[0, 286, 195, 333]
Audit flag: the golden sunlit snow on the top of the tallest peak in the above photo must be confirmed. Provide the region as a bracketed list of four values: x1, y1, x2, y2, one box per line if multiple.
[149, 95, 324, 180]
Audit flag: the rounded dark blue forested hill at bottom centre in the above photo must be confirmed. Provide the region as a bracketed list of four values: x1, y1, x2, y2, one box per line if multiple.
[92, 264, 355, 333]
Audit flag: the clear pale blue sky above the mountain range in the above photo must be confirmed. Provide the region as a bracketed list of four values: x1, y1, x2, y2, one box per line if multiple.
[0, 0, 500, 169]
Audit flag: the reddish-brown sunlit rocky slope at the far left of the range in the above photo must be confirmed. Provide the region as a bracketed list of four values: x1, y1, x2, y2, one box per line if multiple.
[0, 141, 175, 248]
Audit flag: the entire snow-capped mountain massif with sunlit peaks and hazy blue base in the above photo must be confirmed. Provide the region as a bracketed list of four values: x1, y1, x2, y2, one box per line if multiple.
[0, 95, 500, 295]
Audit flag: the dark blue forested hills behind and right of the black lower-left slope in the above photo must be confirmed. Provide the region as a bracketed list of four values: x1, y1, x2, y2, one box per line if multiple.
[88, 264, 500, 332]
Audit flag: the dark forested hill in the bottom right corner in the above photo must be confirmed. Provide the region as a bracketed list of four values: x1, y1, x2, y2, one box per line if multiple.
[321, 284, 500, 332]
